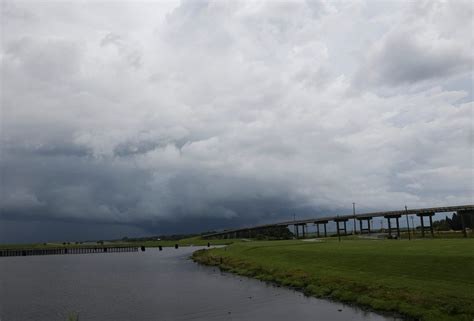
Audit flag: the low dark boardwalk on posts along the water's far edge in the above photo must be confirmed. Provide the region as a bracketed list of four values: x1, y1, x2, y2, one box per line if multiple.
[0, 246, 139, 257]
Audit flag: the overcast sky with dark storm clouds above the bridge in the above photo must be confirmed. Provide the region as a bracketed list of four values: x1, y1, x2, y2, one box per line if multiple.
[0, 0, 474, 242]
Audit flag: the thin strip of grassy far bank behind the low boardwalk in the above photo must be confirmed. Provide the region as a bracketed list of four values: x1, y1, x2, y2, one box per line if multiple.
[0, 237, 240, 250]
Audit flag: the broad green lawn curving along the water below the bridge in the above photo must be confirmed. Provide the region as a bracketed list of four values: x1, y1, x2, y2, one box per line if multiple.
[193, 239, 474, 321]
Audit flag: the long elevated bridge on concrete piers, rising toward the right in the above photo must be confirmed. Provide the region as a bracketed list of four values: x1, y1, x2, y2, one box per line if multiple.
[203, 205, 474, 239]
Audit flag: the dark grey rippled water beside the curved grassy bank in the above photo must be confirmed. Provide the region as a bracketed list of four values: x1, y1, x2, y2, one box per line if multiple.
[0, 248, 400, 321]
